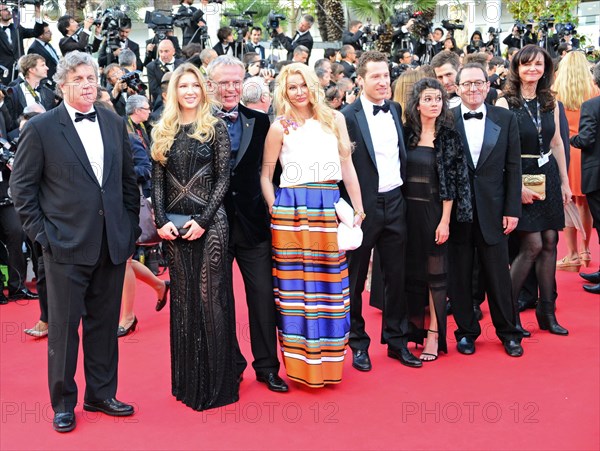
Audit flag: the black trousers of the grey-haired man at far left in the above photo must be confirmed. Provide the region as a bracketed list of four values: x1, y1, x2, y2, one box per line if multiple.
[44, 236, 125, 412]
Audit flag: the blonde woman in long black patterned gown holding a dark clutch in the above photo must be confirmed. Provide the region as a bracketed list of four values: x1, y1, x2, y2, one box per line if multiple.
[152, 64, 239, 410]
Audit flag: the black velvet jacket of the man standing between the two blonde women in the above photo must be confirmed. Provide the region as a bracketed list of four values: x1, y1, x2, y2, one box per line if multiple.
[225, 104, 271, 245]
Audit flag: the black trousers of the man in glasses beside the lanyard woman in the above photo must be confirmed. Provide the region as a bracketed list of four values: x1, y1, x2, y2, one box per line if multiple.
[448, 217, 522, 341]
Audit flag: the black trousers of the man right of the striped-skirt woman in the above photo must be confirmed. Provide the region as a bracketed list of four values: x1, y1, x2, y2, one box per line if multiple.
[347, 188, 408, 350]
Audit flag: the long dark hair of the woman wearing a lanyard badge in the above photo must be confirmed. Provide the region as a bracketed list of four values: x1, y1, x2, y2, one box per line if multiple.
[502, 44, 556, 112]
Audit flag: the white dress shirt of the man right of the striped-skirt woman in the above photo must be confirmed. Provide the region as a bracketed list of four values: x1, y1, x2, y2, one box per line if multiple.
[360, 95, 402, 193]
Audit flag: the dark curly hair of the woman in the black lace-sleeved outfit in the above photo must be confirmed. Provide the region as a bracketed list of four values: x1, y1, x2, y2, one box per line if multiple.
[406, 78, 452, 147]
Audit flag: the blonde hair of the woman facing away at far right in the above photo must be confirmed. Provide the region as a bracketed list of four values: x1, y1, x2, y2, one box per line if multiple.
[552, 52, 596, 111]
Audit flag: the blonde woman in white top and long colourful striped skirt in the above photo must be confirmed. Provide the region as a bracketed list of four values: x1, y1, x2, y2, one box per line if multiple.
[261, 64, 364, 387]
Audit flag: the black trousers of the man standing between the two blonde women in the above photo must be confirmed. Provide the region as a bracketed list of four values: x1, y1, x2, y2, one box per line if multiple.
[227, 219, 279, 376]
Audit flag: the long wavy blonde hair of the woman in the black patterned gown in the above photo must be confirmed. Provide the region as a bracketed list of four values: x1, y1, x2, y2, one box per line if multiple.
[151, 63, 218, 165]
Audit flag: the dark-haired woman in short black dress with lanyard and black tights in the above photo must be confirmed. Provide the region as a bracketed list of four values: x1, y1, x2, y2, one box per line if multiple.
[496, 44, 571, 335]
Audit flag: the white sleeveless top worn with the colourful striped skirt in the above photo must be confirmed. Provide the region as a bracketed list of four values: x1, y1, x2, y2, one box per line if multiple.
[278, 119, 342, 188]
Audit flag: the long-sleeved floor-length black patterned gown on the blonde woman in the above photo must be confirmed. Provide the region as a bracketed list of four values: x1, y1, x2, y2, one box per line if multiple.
[153, 121, 239, 410]
